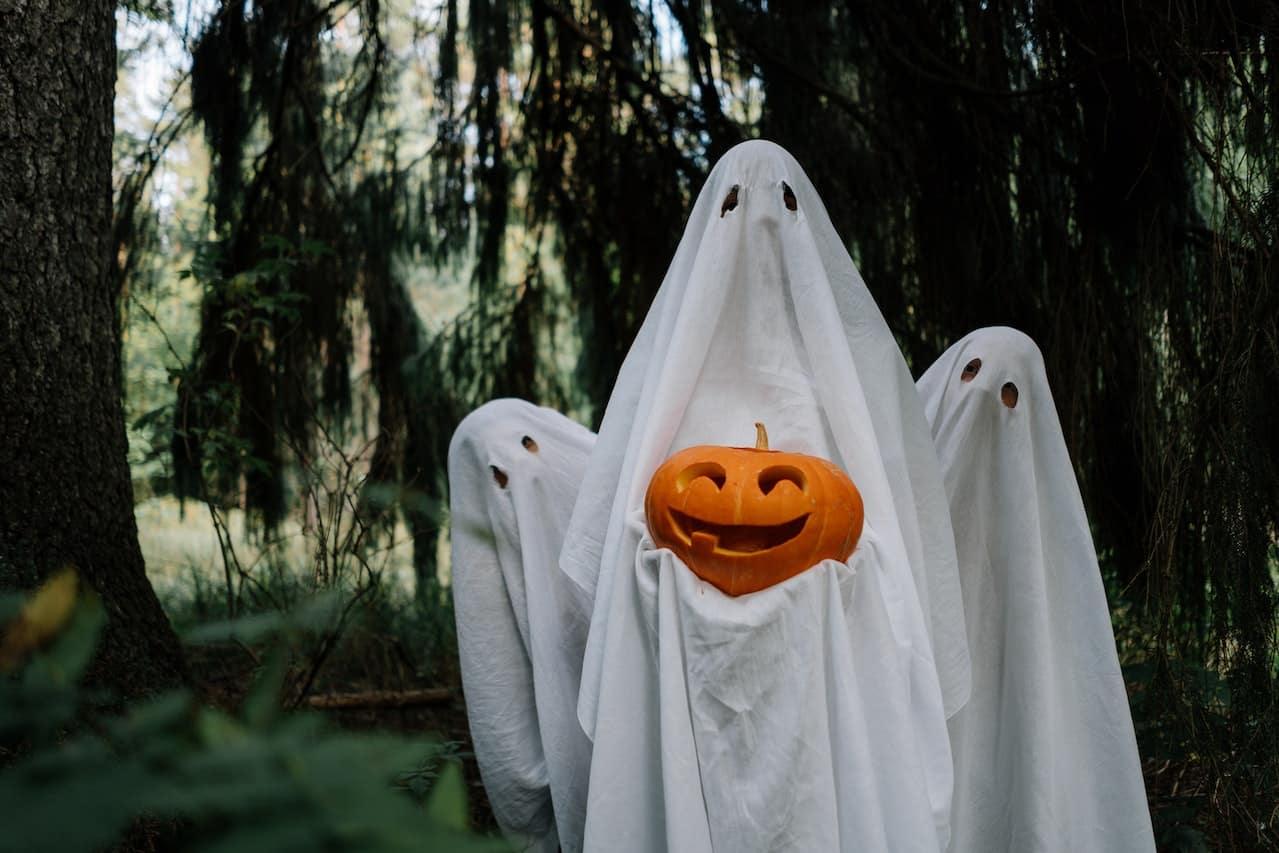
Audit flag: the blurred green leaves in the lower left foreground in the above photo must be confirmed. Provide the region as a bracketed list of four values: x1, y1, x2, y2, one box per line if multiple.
[0, 578, 510, 853]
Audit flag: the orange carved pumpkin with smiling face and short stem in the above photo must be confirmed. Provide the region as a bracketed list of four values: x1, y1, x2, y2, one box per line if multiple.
[645, 423, 863, 596]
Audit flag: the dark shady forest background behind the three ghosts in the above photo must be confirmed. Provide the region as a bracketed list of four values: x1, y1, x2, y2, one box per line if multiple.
[0, 0, 1279, 850]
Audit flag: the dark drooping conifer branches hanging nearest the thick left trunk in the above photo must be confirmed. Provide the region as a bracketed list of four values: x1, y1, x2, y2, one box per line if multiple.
[174, 0, 414, 531]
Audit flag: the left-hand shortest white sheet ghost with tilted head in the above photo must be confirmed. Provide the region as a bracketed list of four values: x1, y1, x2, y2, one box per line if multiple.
[449, 399, 595, 853]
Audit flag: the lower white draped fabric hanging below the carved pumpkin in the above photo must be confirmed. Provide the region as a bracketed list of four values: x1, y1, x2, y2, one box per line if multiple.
[586, 524, 950, 853]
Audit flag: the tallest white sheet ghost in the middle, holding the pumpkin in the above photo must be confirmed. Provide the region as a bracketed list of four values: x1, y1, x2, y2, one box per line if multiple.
[560, 141, 968, 853]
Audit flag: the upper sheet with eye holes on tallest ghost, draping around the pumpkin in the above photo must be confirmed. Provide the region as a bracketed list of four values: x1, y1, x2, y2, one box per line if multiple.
[560, 141, 968, 733]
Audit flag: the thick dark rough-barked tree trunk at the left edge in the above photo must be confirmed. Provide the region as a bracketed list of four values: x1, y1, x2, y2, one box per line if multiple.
[0, 0, 184, 696]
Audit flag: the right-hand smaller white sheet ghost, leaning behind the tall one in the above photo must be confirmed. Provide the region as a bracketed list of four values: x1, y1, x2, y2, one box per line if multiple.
[918, 329, 1155, 853]
